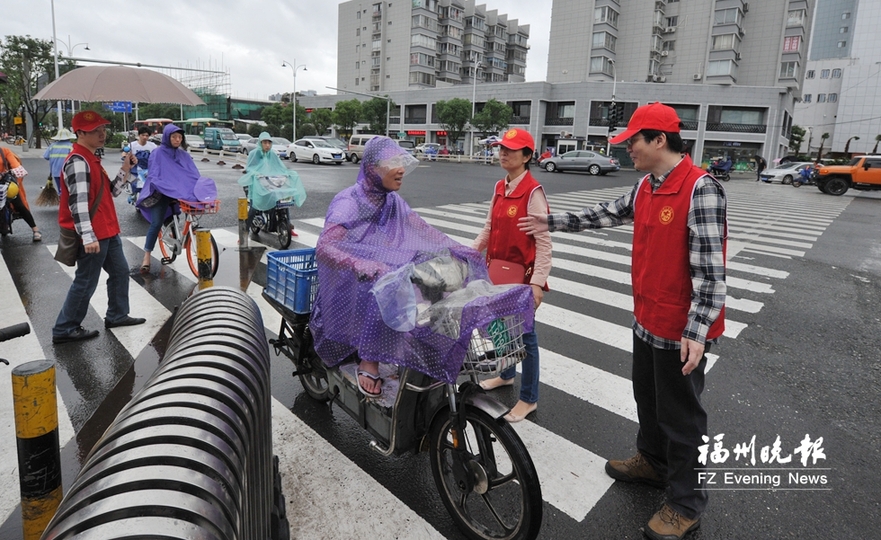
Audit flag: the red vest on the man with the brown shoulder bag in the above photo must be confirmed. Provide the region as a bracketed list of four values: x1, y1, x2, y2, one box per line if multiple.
[58, 143, 119, 240]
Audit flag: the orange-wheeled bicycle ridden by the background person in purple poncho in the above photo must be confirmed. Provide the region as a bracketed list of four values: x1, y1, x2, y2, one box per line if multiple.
[158, 200, 220, 277]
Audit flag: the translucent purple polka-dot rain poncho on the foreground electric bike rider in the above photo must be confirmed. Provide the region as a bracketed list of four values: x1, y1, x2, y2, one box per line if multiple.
[310, 137, 534, 383]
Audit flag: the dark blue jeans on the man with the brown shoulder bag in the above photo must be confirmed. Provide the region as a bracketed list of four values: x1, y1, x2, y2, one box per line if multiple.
[52, 235, 129, 337]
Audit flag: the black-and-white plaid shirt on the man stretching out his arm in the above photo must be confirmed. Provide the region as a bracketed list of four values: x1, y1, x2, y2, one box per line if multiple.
[548, 164, 728, 349]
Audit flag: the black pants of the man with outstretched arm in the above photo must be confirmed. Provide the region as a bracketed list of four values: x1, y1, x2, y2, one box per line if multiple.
[632, 334, 710, 519]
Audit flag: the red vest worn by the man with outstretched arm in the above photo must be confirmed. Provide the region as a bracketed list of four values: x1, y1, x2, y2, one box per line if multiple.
[631, 156, 728, 341]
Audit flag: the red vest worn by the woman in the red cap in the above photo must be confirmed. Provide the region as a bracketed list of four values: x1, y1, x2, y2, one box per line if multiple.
[486, 171, 547, 288]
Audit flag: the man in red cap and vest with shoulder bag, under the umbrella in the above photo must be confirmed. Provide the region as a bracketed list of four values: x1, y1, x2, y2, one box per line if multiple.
[52, 111, 145, 343]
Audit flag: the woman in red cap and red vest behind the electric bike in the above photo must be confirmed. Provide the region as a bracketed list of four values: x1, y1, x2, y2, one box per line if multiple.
[471, 129, 551, 422]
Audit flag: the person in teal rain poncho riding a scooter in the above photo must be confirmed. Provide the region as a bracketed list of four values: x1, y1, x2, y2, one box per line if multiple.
[239, 131, 306, 235]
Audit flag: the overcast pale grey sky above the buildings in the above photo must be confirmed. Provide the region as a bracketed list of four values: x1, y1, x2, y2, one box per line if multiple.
[8, 0, 552, 99]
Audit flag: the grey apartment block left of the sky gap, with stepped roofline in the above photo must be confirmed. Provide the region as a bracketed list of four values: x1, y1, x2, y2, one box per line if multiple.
[337, 0, 529, 93]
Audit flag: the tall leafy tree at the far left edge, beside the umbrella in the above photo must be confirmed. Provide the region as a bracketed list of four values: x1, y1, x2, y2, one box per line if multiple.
[0, 36, 55, 148]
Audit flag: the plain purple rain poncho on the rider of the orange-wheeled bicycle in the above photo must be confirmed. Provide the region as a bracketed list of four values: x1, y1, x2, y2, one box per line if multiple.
[138, 124, 199, 207]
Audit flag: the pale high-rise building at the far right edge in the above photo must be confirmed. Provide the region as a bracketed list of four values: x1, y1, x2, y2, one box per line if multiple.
[794, 0, 881, 154]
